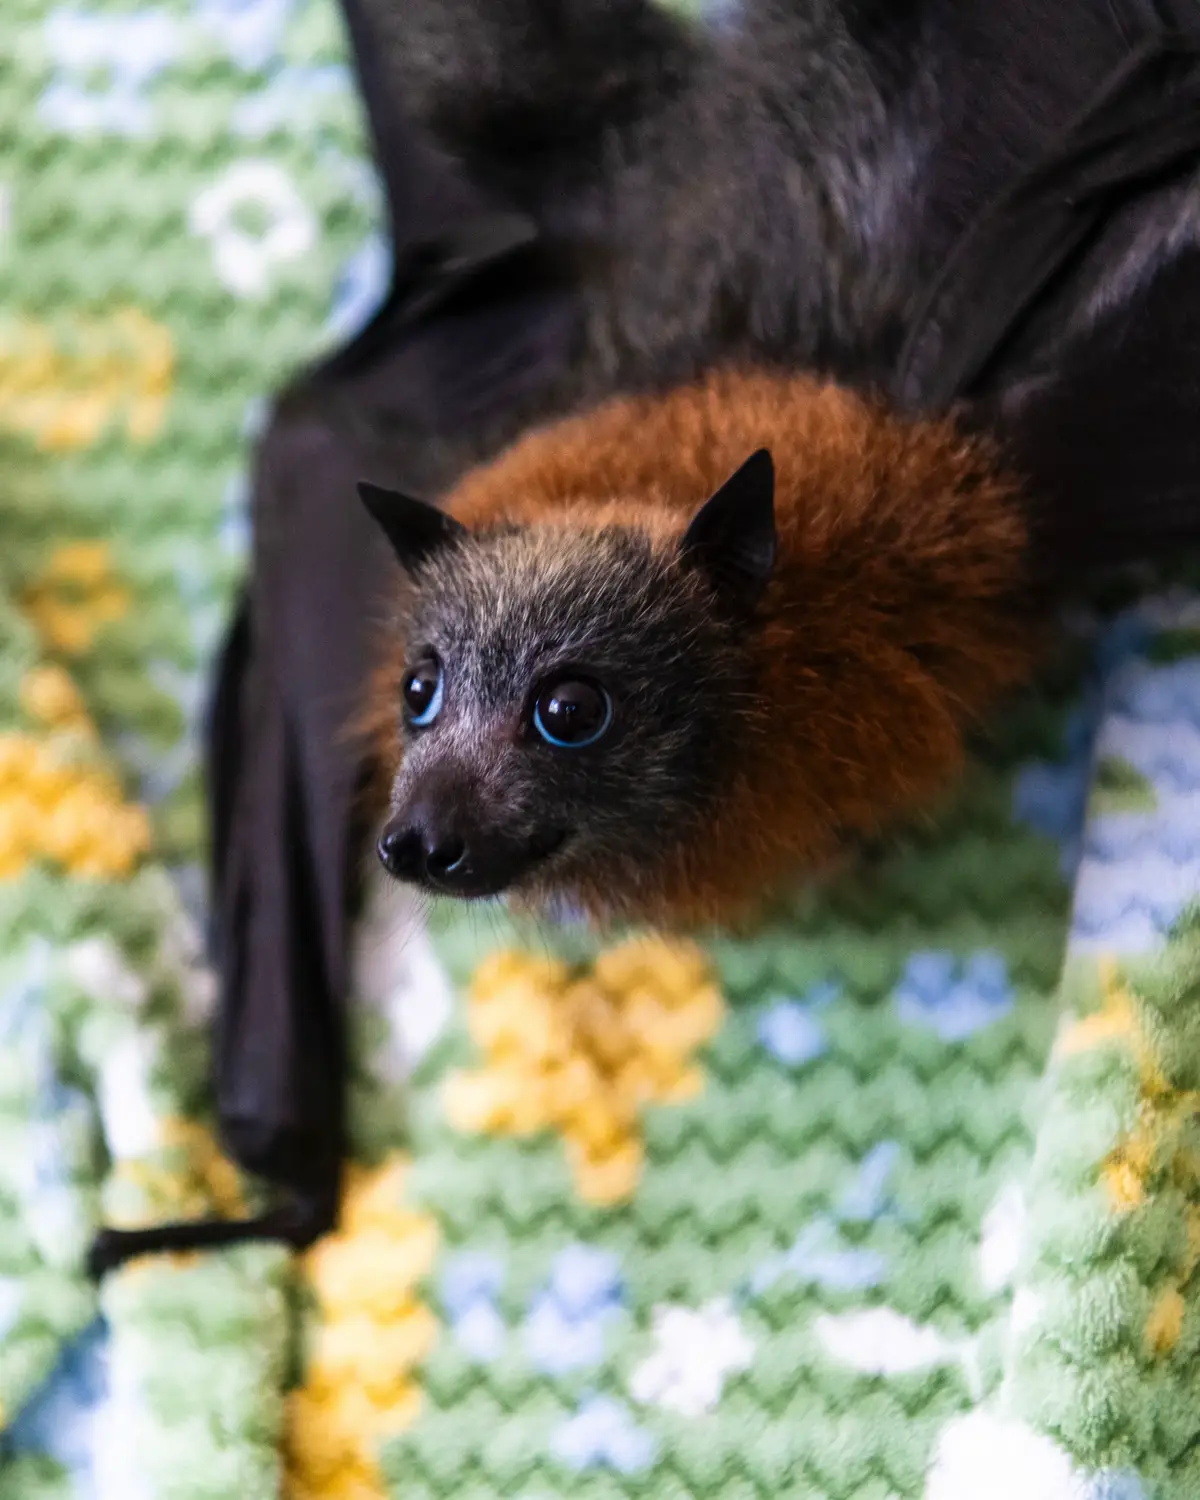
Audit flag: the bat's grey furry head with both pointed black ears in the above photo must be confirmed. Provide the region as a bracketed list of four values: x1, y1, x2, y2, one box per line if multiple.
[360, 452, 776, 914]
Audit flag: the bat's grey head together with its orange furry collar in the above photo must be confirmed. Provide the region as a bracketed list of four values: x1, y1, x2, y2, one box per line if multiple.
[365, 371, 1034, 924]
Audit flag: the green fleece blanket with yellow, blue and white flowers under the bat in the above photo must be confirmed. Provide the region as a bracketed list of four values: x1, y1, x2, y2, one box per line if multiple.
[0, 0, 1200, 1500]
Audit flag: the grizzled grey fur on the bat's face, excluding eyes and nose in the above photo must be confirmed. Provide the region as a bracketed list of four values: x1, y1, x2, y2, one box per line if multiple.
[392, 525, 753, 897]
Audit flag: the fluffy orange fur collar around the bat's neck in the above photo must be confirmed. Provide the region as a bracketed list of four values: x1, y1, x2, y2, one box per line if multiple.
[372, 372, 1034, 923]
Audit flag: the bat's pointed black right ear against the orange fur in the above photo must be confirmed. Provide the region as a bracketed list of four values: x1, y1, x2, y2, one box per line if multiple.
[681, 449, 777, 608]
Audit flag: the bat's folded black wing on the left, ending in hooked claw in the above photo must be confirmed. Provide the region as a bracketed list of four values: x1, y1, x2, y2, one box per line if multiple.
[92, 0, 576, 1274]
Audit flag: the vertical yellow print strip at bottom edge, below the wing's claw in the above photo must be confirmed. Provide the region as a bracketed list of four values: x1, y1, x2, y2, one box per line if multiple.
[284, 1157, 438, 1500]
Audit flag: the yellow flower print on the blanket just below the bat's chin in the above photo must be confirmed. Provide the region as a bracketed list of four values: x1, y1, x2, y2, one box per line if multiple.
[444, 938, 725, 1205]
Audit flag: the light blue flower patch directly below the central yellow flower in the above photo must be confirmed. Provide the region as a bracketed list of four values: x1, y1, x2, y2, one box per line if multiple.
[525, 1245, 624, 1376]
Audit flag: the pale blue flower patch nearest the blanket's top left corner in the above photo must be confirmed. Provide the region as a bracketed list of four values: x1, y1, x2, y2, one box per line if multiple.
[38, 8, 179, 137]
